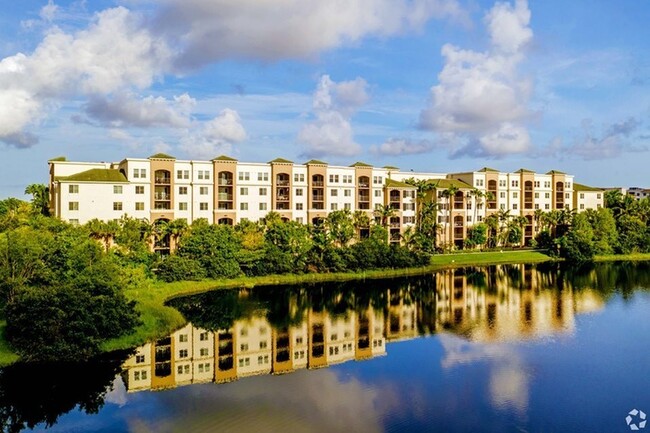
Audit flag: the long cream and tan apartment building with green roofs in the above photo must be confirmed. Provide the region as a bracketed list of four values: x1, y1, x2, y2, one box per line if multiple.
[49, 153, 604, 245]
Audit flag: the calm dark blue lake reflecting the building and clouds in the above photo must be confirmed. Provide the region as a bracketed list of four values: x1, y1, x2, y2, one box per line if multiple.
[0, 264, 650, 432]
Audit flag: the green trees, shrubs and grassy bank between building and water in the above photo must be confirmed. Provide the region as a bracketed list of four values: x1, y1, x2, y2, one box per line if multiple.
[0, 186, 650, 364]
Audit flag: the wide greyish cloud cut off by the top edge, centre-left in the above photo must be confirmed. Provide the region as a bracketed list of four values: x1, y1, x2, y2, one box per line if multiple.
[152, 0, 467, 70]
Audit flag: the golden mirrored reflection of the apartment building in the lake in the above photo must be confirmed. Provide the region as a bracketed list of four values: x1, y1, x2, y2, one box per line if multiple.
[122, 265, 604, 392]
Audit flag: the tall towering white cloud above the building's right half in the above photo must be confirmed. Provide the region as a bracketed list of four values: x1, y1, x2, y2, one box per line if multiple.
[420, 0, 533, 157]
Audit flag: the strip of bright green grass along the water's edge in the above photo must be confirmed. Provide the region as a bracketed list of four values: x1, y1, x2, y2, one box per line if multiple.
[0, 250, 650, 366]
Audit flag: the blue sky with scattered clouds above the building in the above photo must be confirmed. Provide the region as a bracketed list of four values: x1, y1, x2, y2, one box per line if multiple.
[0, 0, 650, 198]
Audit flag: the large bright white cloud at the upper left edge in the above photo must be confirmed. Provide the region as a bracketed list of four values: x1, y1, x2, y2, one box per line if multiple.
[0, 4, 171, 145]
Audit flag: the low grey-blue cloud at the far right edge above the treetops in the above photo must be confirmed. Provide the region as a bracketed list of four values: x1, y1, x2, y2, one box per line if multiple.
[537, 117, 650, 160]
